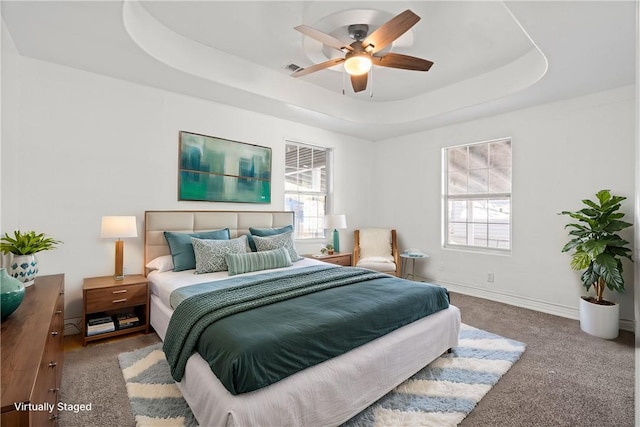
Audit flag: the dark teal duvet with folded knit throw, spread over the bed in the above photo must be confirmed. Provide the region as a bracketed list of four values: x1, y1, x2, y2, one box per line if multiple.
[163, 266, 449, 394]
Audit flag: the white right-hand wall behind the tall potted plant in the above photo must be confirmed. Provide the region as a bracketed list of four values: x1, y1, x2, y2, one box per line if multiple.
[374, 87, 636, 327]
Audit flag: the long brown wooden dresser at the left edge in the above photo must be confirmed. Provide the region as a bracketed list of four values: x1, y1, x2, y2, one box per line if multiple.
[0, 274, 64, 427]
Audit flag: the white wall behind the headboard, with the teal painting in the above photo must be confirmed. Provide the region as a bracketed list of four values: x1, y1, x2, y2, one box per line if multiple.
[1, 56, 373, 318]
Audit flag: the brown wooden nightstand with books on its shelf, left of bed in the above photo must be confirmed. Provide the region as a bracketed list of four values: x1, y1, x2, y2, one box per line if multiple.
[82, 274, 149, 345]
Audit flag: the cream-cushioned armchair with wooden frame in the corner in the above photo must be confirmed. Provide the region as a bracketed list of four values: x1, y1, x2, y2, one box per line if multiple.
[352, 228, 400, 276]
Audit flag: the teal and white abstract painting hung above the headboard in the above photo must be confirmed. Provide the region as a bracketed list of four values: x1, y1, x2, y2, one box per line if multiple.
[178, 131, 271, 203]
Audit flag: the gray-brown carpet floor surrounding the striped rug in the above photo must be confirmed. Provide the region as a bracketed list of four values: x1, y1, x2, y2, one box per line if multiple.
[59, 294, 634, 427]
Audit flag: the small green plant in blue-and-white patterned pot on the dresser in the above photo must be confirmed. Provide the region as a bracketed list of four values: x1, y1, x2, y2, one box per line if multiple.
[0, 230, 62, 286]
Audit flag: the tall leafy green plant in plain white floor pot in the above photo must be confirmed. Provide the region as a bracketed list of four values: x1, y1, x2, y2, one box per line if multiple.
[560, 190, 633, 339]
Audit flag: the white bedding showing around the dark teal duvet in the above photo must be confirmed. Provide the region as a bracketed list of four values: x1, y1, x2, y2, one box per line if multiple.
[148, 259, 460, 426]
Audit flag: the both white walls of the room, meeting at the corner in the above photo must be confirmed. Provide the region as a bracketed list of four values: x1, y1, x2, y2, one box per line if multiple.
[0, 33, 635, 332]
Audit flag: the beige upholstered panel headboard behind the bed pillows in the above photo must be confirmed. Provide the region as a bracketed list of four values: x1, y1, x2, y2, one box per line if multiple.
[144, 211, 294, 265]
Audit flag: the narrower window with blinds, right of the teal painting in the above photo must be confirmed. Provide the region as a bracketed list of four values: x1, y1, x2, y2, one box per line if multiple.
[284, 141, 330, 239]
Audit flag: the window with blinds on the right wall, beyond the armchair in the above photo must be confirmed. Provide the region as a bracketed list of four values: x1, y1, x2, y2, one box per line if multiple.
[443, 139, 511, 251]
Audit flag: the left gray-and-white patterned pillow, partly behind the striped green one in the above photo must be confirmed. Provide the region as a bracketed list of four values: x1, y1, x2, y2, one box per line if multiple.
[191, 236, 247, 274]
